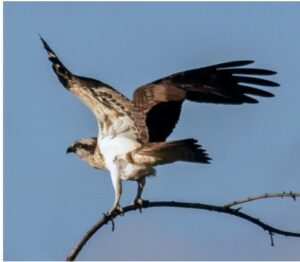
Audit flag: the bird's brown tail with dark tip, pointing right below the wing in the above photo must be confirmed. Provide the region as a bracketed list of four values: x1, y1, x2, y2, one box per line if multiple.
[132, 139, 211, 165]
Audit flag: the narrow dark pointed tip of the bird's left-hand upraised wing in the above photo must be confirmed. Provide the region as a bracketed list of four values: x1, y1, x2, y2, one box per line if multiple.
[40, 36, 73, 89]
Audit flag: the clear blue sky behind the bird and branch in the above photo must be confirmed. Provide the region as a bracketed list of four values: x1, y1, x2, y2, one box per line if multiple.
[4, 2, 300, 260]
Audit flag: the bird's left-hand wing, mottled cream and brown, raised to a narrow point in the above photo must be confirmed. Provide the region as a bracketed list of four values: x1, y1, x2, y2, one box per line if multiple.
[41, 38, 148, 143]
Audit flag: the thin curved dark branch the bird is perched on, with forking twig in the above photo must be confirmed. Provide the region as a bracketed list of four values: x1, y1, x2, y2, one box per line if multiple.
[66, 192, 300, 261]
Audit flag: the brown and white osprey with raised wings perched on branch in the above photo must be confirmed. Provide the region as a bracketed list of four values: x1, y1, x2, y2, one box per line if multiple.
[41, 38, 278, 214]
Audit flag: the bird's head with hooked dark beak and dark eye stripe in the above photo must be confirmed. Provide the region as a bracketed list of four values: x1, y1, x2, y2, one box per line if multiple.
[67, 137, 106, 169]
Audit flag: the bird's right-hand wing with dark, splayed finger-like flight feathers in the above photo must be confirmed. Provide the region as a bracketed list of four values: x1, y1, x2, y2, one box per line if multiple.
[133, 61, 278, 142]
